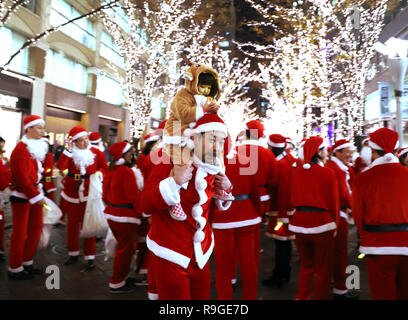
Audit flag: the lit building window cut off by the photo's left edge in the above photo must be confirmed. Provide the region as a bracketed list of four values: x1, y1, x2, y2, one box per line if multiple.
[0, 26, 28, 74]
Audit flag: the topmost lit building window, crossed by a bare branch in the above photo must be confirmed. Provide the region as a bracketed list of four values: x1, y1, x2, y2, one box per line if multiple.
[50, 0, 96, 50]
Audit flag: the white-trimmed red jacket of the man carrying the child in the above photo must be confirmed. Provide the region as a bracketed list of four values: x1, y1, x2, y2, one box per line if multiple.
[142, 152, 226, 269]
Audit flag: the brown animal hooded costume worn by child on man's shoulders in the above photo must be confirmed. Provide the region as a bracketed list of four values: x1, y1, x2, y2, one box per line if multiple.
[163, 63, 220, 165]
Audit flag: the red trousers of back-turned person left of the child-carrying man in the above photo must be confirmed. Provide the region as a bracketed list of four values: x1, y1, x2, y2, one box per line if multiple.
[108, 219, 137, 289]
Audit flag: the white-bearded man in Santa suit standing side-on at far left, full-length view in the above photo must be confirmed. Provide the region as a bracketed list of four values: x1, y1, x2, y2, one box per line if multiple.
[8, 115, 48, 280]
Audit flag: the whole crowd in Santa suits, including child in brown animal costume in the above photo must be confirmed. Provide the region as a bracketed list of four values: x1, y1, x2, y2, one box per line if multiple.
[0, 64, 408, 300]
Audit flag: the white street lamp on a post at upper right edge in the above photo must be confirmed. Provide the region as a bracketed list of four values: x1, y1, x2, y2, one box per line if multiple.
[374, 37, 408, 147]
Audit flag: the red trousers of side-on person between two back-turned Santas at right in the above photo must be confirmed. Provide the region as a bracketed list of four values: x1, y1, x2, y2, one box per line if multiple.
[333, 217, 348, 294]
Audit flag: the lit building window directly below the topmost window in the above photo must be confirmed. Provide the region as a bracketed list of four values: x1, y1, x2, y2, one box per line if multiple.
[44, 50, 88, 93]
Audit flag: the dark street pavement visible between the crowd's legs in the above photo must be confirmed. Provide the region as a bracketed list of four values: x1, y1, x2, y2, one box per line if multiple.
[0, 182, 370, 300]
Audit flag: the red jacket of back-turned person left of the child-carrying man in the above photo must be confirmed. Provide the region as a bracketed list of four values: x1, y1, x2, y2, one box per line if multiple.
[102, 165, 143, 224]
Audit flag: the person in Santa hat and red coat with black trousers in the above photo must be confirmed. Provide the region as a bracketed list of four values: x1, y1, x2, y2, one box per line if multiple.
[263, 134, 295, 287]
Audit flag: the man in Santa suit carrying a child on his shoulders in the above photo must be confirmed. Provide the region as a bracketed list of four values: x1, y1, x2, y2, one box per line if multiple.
[142, 114, 231, 300]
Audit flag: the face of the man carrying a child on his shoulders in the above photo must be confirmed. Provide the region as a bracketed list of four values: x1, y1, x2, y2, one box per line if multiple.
[194, 131, 226, 164]
